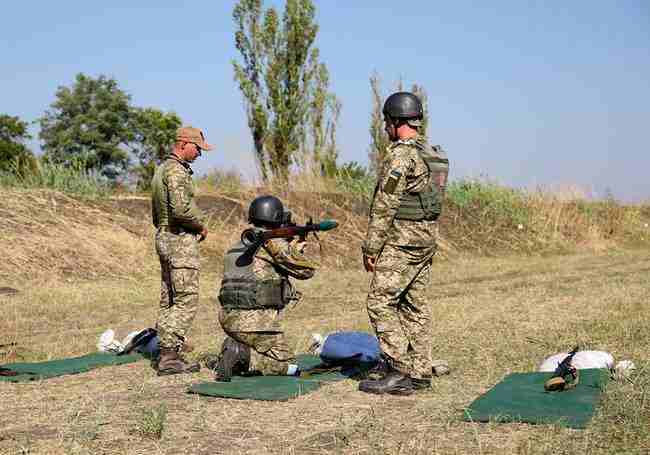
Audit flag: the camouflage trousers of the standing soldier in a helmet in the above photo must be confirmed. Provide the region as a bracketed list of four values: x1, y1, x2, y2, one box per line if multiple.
[366, 245, 433, 379]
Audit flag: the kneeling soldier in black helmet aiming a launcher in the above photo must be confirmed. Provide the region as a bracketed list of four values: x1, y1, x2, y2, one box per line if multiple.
[215, 196, 317, 381]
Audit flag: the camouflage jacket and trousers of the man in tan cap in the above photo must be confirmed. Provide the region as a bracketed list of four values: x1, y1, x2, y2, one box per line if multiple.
[151, 155, 204, 350]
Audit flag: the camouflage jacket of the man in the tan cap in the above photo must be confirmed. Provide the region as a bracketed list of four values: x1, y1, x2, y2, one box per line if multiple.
[151, 155, 205, 233]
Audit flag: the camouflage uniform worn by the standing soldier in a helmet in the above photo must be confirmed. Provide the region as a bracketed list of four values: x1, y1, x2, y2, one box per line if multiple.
[362, 136, 449, 379]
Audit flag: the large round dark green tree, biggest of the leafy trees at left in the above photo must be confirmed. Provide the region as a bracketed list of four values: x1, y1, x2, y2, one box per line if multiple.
[39, 73, 133, 173]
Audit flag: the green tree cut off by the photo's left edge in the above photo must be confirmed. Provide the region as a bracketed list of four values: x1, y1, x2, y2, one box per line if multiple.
[0, 114, 37, 174]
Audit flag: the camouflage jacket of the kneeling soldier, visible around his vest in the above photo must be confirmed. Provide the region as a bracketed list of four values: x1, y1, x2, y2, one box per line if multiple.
[219, 239, 320, 332]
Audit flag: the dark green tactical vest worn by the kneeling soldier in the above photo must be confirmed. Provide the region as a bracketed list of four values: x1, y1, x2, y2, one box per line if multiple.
[219, 242, 291, 310]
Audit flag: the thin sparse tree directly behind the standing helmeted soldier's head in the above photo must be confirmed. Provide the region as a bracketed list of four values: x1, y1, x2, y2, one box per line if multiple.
[368, 73, 429, 175]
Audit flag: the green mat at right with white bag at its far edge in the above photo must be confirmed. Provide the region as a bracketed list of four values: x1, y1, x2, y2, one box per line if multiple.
[464, 369, 609, 428]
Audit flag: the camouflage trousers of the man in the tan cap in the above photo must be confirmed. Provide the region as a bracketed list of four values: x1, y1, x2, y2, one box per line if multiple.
[156, 231, 200, 350]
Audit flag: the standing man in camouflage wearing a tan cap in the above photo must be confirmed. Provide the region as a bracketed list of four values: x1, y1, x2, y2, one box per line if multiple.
[151, 127, 212, 376]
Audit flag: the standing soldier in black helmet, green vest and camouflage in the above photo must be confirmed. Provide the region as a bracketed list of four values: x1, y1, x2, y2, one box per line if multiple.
[359, 92, 449, 395]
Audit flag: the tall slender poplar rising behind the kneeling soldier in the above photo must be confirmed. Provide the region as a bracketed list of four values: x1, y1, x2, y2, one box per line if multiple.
[232, 0, 340, 181]
